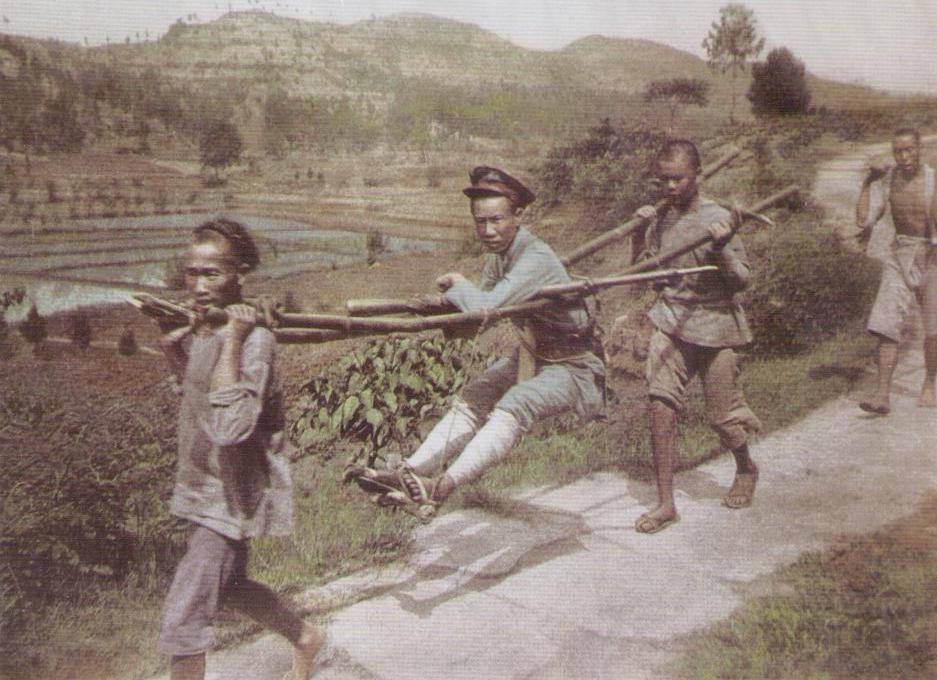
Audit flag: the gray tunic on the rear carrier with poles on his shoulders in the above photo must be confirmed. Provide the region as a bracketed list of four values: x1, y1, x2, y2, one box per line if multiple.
[647, 197, 752, 347]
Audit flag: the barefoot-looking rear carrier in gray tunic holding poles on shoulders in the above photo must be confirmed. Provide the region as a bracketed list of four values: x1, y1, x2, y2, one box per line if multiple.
[635, 140, 761, 533]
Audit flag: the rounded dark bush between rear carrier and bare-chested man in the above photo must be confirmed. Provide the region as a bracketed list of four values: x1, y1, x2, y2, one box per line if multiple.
[745, 208, 879, 356]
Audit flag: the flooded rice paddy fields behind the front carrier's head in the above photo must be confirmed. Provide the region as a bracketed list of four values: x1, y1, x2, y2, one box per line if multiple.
[0, 213, 445, 321]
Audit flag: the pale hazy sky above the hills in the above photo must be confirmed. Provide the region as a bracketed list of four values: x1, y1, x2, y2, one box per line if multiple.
[0, 0, 937, 94]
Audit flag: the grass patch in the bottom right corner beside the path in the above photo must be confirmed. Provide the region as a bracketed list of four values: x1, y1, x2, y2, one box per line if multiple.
[674, 496, 937, 680]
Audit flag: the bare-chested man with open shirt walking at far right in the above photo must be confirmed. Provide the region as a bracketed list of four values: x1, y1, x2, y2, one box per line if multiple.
[856, 128, 937, 415]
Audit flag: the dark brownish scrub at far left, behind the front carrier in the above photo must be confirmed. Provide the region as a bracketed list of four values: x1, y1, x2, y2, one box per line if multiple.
[0, 393, 181, 639]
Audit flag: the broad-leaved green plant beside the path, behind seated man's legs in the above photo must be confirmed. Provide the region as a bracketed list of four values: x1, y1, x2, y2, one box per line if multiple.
[291, 336, 472, 465]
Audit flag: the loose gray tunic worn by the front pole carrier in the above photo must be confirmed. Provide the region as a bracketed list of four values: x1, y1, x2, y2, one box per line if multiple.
[169, 327, 293, 540]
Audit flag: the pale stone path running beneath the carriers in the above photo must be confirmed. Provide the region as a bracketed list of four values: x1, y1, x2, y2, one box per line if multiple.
[154, 141, 937, 680]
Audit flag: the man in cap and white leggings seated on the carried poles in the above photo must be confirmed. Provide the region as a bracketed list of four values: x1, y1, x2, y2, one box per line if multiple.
[352, 166, 605, 519]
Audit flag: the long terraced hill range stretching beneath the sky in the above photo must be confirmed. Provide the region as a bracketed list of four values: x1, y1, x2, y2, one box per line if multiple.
[0, 11, 920, 157]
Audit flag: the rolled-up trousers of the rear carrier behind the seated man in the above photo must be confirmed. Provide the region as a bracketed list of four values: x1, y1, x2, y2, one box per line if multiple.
[646, 330, 761, 451]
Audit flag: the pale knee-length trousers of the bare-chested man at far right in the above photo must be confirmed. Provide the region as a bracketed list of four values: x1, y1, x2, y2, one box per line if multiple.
[868, 235, 937, 342]
